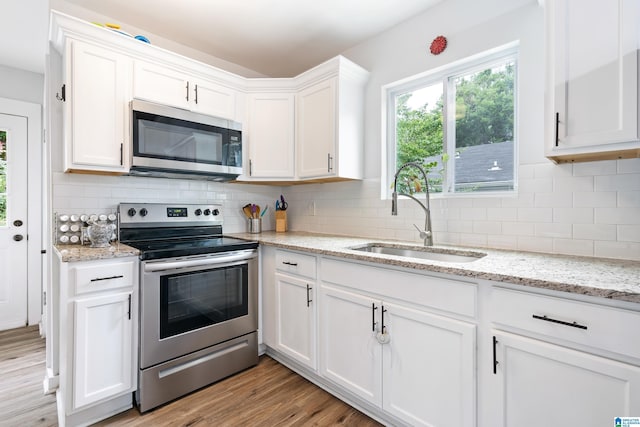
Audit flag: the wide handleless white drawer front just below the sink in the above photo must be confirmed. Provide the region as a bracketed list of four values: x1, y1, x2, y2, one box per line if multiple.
[321, 258, 477, 317]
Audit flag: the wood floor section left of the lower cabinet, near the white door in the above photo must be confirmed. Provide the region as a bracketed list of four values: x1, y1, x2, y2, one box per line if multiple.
[0, 326, 58, 427]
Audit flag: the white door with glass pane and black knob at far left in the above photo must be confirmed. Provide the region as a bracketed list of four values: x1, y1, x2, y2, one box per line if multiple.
[0, 114, 27, 330]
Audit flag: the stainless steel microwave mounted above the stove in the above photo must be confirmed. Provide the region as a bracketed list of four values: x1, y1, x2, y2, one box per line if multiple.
[130, 99, 242, 181]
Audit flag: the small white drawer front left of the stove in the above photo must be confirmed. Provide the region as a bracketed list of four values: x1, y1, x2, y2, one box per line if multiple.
[71, 260, 138, 295]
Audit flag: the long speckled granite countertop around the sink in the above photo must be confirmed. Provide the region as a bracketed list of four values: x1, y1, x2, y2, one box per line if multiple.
[231, 231, 640, 303]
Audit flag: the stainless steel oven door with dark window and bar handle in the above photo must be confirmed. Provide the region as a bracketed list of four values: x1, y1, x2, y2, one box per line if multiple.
[140, 250, 258, 369]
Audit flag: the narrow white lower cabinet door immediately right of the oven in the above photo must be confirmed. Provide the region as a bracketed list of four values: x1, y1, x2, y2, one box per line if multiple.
[276, 274, 316, 370]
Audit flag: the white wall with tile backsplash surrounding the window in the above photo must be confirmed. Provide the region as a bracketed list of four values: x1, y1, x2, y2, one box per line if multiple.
[284, 0, 640, 260]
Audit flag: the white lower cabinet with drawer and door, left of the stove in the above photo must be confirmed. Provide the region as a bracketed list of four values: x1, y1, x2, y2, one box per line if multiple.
[54, 257, 139, 427]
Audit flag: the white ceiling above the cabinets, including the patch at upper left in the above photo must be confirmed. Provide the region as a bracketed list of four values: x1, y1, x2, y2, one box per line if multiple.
[0, 0, 442, 77]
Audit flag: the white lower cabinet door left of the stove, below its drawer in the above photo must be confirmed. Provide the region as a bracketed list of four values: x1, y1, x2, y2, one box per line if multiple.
[73, 292, 135, 408]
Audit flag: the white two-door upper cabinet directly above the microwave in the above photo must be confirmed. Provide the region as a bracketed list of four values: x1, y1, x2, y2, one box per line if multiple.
[133, 61, 236, 120]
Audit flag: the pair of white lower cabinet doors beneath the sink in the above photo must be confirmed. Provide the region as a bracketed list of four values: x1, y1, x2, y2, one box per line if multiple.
[320, 285, 476, 426]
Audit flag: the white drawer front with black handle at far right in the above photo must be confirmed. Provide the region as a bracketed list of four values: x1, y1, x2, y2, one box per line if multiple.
[488, 288, 640, 358]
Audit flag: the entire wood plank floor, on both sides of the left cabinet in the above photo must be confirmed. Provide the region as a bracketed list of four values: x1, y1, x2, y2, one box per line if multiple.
[0, 328, 380, 427]
